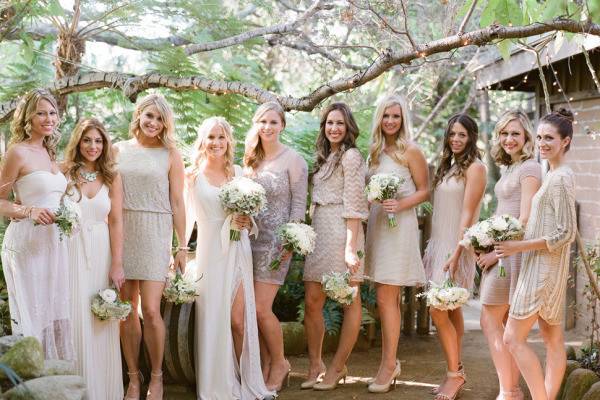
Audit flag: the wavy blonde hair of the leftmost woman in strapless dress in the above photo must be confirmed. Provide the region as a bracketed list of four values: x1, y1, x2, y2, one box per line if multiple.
[8, 89, 60, 161]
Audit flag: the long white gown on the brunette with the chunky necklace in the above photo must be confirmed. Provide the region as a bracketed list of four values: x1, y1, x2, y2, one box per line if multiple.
[68, 185, 123, 400]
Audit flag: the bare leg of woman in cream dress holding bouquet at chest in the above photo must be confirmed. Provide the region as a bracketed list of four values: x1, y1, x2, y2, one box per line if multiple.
[375, 284, 402, 385]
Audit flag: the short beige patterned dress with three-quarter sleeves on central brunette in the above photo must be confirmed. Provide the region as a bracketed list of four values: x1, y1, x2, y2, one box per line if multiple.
[303, 149, 369, 283]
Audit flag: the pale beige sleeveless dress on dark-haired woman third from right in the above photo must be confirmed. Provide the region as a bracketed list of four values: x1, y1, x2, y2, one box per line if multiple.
[423, 161, 481, 290]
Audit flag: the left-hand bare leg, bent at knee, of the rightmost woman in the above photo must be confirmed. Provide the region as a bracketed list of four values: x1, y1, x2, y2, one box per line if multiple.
[504, 314, 548, 400]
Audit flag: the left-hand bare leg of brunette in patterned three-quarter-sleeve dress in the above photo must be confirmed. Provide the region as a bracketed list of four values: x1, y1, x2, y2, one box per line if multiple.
[304, 281, 327, 381]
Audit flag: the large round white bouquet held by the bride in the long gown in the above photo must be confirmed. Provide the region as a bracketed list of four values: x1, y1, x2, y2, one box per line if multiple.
[219, 176, 267, 241]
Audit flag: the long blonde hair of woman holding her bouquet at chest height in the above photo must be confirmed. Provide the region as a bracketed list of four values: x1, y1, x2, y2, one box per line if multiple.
[369, 95, 412, 169]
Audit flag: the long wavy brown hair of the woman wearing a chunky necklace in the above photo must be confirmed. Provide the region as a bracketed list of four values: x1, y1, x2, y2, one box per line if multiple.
[64, 118, 117, 200]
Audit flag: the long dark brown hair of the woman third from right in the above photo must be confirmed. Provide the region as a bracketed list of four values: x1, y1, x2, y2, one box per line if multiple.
[433, 114, 481, 188]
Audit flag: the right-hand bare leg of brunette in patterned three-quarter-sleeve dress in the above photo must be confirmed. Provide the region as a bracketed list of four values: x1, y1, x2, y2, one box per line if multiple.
[323, 282, 362, 385]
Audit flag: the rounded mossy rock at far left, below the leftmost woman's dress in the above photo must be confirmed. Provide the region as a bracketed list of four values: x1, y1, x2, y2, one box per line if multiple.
[0, 336, 44, 379]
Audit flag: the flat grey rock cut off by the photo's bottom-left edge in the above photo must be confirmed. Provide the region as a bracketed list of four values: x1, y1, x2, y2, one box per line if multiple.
[4, 375, 87, 400]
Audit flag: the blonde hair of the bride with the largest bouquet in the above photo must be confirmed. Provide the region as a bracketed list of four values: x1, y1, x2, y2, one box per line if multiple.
[191, 117, 235, 180]
